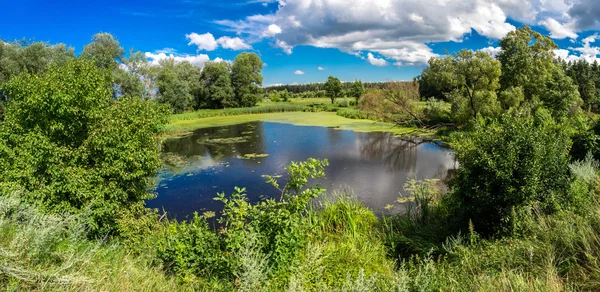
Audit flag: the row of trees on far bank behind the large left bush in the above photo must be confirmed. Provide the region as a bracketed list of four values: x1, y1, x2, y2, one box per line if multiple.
[0, 33, 263, 113]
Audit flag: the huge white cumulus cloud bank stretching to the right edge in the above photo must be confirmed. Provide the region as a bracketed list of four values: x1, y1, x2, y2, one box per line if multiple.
[216, 0, 600, 65]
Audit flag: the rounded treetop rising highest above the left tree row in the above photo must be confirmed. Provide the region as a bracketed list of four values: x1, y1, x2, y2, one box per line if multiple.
[81, 33, 125, 70]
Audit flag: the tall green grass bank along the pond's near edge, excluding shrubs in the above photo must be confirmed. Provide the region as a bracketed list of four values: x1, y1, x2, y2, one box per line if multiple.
[0, 180, 600, 291]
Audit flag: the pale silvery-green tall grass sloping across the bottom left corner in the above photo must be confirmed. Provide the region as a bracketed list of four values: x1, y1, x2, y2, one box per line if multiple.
[0, 193, 193, 291]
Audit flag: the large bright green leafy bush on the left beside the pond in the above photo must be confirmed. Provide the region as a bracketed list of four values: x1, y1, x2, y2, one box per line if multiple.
[0, 60, 167, 235]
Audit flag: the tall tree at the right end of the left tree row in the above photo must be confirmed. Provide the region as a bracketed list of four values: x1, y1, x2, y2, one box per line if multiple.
[231, 52, 263, 107]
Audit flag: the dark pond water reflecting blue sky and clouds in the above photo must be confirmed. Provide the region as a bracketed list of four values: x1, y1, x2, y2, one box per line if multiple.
[147, 122, 455, 219]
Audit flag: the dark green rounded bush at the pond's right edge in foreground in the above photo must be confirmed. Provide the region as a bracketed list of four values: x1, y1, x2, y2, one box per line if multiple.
[453, 112, 570, 234]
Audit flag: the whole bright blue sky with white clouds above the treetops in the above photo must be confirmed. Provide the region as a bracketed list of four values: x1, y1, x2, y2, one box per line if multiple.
[0, 0, 600, 85]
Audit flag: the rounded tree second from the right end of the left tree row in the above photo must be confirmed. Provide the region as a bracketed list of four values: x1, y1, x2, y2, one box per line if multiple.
[195, 62, 238, 108]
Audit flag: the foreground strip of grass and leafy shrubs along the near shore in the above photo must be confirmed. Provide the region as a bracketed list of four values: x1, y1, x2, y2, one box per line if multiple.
[0, 141, 600, 291]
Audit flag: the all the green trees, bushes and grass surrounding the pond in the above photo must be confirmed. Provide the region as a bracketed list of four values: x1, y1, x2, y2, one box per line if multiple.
[0, 26, 600, 292]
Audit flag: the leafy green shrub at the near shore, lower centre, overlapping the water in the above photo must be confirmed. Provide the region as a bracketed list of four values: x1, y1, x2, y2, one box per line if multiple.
[158, 158, 328, 284]
